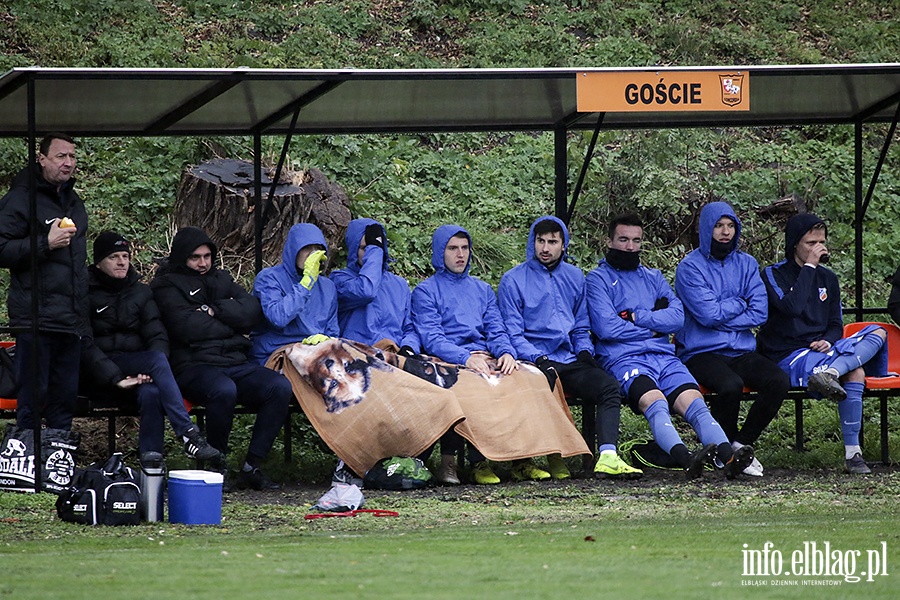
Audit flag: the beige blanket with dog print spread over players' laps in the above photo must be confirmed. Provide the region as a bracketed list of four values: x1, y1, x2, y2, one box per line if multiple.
[267, 339, 590, 474]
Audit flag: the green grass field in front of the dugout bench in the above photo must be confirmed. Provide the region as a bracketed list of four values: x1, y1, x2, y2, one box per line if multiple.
[0, 469, 900, 599]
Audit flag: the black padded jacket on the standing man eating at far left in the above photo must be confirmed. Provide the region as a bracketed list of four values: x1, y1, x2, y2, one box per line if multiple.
[0, 165, 89, 336]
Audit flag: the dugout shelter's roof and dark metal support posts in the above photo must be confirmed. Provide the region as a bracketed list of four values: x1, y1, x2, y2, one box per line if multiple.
[0, 63, 900, 487]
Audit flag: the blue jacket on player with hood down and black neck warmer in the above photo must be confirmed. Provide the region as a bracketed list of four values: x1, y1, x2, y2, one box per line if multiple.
[585, 246, 684, 372]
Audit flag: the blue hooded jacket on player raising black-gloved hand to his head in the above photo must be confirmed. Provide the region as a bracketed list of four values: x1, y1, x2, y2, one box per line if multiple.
[331, 219, 420, 352]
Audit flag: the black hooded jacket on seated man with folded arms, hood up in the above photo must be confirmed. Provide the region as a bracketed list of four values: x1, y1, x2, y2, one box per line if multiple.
[150, 227, 263, 374]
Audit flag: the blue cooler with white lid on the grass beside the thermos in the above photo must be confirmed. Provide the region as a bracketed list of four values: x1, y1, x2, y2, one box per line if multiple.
[169, 470, 223, 525]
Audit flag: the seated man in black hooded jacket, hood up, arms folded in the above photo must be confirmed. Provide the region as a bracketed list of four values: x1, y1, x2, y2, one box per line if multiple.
[150, 227, 294, 490]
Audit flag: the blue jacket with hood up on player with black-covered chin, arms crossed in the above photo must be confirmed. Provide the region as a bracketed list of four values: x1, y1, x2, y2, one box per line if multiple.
[675, 202, 769, 362]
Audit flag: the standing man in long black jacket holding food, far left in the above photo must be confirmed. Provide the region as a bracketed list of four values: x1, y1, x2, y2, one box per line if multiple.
[0, 133, 88, 430]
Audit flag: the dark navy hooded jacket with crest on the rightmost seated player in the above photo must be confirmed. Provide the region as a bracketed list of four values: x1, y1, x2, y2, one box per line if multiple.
[757, 214, 844, 362]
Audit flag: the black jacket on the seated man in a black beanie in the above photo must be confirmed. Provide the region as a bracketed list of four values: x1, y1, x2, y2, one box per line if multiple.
[81, 266, 169, 386]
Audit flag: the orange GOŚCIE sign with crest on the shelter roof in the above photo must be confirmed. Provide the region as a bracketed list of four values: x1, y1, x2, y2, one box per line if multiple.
[575, 71, 750, 112]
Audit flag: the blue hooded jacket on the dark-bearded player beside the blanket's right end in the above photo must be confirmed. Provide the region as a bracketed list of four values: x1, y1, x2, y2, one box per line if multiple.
[497, 216, 594, 363]
